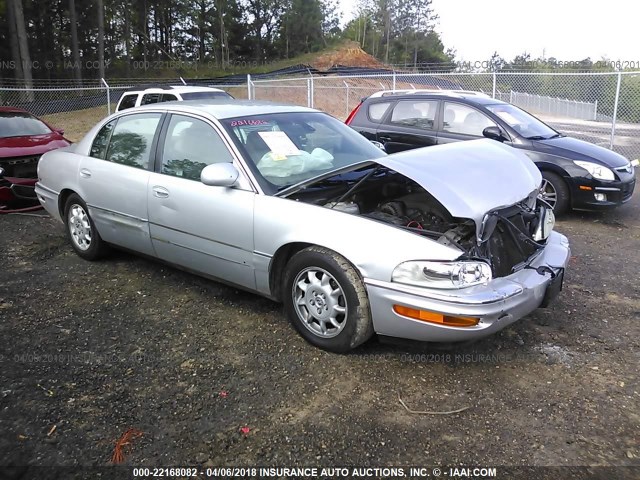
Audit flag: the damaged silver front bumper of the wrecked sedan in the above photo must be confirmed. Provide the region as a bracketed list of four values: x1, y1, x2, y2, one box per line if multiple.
[364, 232, 571, 342]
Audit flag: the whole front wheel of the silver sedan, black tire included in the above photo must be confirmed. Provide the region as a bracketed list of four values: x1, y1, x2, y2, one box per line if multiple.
[282, 247, 373, 353]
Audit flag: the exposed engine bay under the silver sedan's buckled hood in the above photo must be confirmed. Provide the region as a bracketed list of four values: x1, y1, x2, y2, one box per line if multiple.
[288, 167, 554, 277]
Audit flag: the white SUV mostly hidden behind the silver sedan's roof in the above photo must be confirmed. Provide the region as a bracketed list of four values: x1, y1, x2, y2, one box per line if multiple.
[116, 85, 233, 112]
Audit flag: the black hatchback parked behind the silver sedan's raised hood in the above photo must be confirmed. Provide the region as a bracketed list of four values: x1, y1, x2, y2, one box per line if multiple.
[346, 90, 635, 213]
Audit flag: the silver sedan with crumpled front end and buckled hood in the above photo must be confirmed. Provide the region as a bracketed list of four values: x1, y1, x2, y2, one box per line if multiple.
[36, 102, 570, 352]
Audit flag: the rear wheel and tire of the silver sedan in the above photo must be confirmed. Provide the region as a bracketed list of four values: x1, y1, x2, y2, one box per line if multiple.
[64, 193, 108, 260]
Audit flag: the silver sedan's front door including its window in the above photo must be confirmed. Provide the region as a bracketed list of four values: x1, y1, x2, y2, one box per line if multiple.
[147, 114, 256, 289]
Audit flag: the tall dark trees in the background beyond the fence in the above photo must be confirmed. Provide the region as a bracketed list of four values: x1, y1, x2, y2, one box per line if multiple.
[0, 0, 453, 83]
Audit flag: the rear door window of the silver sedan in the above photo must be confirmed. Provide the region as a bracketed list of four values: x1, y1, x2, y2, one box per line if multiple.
[106, 113, 162, 169]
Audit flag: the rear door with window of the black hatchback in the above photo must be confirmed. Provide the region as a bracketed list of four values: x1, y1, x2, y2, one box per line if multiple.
[377, 99, 439, 153]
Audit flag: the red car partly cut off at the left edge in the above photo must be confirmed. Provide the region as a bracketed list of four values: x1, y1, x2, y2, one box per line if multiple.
[0, 107, 71, 213]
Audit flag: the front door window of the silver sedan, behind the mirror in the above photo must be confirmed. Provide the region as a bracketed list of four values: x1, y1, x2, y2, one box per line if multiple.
[162, 115, 233, 181]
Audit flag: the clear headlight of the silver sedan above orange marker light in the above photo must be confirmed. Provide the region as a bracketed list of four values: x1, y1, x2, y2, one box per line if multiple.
[391, 260, 492, 289]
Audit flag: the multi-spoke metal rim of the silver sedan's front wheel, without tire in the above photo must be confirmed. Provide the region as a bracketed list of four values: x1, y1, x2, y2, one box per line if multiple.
[291, 267, 348, 338]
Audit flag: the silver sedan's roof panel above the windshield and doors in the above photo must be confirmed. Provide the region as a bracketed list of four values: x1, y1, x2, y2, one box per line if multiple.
[118, 99, 319, 119]
